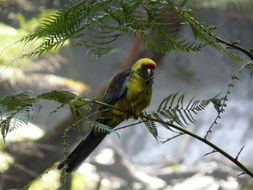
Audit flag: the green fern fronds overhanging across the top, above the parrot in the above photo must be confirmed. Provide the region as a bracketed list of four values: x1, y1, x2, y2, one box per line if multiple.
[18, 0, 241, 60]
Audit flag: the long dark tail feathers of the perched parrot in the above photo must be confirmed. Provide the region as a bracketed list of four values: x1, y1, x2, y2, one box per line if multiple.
[57, 130, 106, 173]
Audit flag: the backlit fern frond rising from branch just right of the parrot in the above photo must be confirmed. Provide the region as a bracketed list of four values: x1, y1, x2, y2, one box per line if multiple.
[155, 92, 213, 128]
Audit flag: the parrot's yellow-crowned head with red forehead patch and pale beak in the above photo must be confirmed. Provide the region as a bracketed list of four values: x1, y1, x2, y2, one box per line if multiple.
[131, 58, 156, 80]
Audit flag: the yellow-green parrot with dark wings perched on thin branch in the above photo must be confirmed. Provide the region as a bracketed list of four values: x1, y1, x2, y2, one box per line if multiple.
[58, 58, 156, 172]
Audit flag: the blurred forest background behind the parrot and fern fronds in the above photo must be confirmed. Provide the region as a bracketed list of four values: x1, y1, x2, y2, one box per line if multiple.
[0, 0, 253, 190]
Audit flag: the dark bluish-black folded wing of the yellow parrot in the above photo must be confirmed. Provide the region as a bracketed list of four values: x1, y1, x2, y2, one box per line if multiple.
[103, 70, 131, 105]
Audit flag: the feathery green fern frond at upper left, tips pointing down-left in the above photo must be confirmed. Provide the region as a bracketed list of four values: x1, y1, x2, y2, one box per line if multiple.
[21, 1, 102, 58]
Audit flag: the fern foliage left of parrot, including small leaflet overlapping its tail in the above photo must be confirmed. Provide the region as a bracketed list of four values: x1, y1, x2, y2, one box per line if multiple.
[0, 90, 113, 140]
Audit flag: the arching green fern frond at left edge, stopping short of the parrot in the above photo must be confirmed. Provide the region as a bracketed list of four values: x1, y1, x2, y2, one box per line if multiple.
[0, 90, 90, 140]
